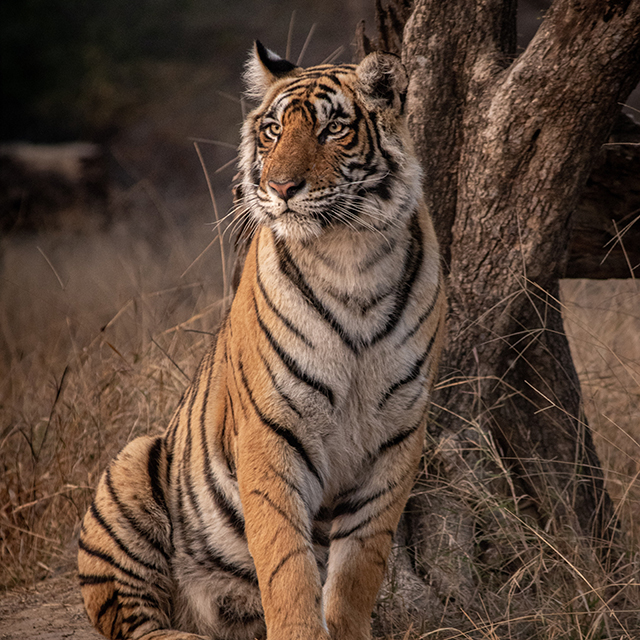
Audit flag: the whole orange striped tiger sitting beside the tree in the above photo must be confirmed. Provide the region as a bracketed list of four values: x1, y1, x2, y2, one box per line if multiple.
[79, 43, 444, 640]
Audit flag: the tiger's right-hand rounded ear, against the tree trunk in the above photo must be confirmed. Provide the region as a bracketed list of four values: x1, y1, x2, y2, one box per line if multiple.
[356, 51, 409, 114]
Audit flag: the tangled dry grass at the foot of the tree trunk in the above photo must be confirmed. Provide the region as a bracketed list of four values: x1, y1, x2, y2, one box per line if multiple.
[376, 416, 640, 640]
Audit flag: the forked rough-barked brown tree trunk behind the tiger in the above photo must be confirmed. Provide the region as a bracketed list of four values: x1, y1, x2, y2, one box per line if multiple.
[357, 0, 640, 637]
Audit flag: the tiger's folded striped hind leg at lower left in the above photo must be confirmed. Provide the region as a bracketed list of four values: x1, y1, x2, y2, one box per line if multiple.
[78, 437, 202, 640]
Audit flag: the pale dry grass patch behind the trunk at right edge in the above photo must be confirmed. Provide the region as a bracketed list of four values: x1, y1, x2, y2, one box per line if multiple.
[562, 280, 640, 548]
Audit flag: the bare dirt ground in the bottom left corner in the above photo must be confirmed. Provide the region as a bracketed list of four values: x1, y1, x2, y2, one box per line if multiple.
[0, 573, 102, 640]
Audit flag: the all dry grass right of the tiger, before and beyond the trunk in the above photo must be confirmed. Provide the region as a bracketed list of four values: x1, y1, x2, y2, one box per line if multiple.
[375, 280, 640, 640]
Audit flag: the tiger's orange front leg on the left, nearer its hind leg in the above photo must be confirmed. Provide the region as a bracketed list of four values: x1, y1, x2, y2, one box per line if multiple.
[238, 423, 329, 640]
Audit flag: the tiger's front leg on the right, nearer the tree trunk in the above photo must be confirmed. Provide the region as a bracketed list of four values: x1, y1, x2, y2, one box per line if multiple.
[324, 428, 424, 640]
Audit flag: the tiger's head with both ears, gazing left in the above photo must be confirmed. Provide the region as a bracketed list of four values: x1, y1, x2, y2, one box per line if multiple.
[240, 42, 421, 242]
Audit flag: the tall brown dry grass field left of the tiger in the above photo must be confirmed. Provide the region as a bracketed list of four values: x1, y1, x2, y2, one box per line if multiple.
[0, 211, 230, 587]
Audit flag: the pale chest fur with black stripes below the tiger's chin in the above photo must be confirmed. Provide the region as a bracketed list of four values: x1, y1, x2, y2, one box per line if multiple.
[252, 216, 439, 493]
